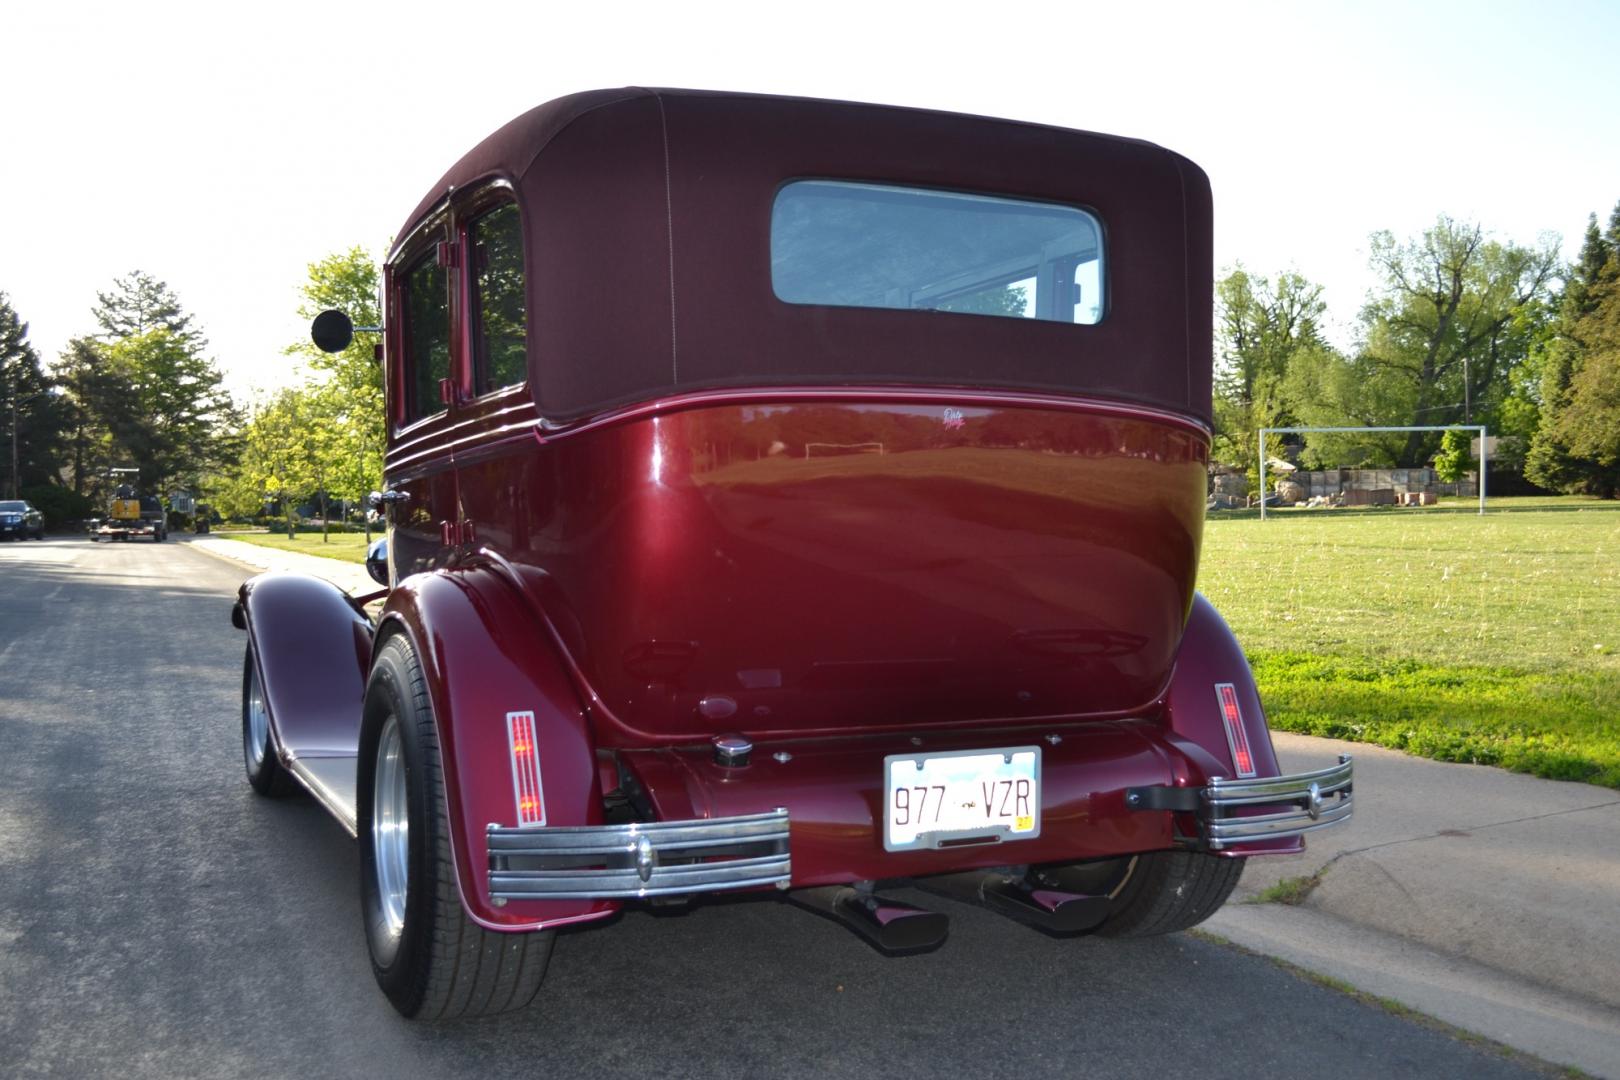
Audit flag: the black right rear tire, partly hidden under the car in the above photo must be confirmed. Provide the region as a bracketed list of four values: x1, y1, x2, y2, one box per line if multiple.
[1097, 852, 1244, 938]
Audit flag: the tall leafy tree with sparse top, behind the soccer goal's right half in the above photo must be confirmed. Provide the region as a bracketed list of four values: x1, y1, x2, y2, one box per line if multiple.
[1361, 215, 1558, 466]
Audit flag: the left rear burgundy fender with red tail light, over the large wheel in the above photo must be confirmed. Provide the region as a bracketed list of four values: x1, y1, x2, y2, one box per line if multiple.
[377, 567, 619, 931]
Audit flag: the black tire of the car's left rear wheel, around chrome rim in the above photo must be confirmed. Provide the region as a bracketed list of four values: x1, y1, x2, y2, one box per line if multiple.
[356, 635, 556, 1020]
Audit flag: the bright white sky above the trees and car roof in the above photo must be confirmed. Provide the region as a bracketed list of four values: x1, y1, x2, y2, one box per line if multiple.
[0, 0, 1620, 397]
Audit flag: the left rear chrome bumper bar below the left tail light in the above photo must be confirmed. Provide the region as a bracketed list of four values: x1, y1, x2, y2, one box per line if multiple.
[486, 810, 792, 900]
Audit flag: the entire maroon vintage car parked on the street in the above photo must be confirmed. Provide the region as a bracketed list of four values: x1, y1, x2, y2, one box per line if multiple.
[233, 89, 1351, 1017]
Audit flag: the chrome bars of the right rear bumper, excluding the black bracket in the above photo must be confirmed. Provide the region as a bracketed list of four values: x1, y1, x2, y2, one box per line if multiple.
[1199, 755, 1354, 850]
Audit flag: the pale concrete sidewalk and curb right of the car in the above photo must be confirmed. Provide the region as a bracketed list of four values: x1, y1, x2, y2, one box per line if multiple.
[1224, 732, 1620, 1080]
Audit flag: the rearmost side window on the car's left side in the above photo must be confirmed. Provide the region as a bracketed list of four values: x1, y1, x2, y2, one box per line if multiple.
[467, 202, 528, 393]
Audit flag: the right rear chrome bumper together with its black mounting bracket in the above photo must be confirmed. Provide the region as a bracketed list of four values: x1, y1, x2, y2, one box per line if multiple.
[1126, 755, 1353, 852]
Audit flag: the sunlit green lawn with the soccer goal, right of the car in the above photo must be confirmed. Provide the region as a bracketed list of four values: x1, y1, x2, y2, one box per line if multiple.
[1199, 499, 1620, 787]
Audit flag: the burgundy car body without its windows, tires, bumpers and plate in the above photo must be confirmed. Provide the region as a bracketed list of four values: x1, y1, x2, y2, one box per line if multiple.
[237, 89, 1348, 929]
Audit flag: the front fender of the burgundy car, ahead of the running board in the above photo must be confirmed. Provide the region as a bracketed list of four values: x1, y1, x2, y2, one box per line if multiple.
[232, 573, 371, 763]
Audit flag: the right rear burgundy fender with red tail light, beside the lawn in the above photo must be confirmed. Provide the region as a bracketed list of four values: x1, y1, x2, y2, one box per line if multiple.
[1165, 593, 1302, 855]
